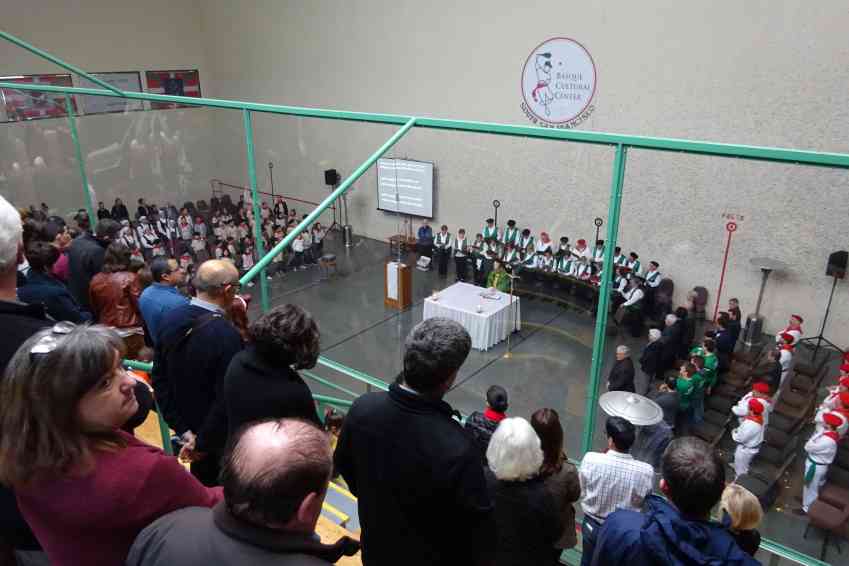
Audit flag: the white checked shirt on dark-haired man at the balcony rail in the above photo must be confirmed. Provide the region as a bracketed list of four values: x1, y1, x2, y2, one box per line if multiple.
[578, 450, 654, 521]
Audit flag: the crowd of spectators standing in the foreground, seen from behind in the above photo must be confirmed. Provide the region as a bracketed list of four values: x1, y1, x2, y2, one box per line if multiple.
[0, 192, 759, 566]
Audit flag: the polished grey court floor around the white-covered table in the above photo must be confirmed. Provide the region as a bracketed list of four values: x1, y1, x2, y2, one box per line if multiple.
[245, 234, 839, 564]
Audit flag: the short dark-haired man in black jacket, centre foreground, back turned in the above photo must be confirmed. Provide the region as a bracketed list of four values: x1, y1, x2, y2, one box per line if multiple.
[335, 318, 496, 566]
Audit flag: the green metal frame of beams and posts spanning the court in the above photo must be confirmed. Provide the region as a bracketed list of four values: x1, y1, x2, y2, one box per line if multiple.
[0, 31, 849, 566]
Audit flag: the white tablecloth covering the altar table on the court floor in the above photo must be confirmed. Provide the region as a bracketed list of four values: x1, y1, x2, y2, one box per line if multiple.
[423, 283, 522, 350]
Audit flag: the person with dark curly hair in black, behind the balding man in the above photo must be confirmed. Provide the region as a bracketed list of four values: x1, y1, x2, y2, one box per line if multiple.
[197, 305, 321, 458]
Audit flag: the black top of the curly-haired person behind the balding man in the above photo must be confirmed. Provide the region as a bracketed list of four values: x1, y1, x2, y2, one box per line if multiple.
[197, 346, 321, 452]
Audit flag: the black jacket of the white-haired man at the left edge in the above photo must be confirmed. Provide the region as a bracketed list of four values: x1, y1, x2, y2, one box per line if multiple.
[0, 301, 53, 550]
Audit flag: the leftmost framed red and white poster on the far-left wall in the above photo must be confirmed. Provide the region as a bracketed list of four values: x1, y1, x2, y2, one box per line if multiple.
[0, 74, 77, 122]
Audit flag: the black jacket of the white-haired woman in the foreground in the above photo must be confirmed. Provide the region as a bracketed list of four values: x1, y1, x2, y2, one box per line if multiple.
[486, 471, 563, 566]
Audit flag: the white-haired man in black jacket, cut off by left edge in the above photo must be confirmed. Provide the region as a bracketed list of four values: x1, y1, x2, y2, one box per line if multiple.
[0, 196, 52, 564]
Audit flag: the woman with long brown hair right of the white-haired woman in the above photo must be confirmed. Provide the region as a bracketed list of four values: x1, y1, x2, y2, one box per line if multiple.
[531, 409, 581, 562]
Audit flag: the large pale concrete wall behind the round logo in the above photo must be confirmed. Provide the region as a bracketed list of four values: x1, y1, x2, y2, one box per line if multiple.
[204, 0, 849, 344]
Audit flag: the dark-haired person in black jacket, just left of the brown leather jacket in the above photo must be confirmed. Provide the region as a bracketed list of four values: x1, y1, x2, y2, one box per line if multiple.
[68, 218, 121, 311]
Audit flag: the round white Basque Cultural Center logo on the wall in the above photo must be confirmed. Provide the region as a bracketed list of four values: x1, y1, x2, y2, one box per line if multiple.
[522, 37, 596, 129]
